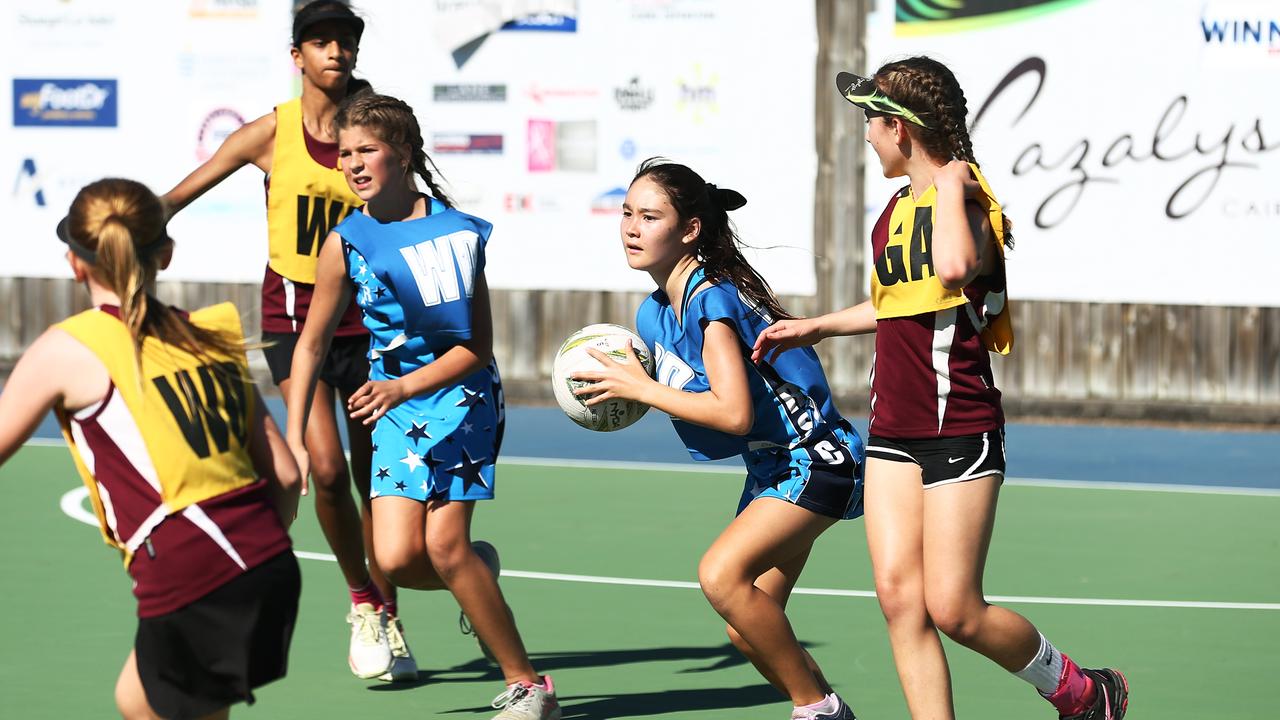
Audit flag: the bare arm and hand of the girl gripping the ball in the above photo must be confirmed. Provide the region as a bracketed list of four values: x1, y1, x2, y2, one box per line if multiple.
[572, 320, 755, 436]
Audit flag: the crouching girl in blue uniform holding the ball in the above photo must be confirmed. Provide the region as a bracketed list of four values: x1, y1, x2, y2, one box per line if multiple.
[573, 159, 863, 720]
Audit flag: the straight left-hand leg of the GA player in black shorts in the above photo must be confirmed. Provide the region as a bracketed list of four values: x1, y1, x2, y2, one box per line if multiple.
[863, 453, 955, 720]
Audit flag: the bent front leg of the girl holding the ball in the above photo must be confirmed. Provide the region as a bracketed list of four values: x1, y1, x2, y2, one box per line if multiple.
[698, 497, 836, 706]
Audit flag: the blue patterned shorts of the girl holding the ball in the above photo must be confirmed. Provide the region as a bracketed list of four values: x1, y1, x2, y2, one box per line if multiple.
[737, 423, 867, 520]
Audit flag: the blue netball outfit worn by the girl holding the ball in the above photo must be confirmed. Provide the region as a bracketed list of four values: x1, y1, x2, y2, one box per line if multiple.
[636, 268, 865, 519]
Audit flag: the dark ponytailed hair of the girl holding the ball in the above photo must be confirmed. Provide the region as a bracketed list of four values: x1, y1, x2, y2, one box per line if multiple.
[631, 158, 791, 320]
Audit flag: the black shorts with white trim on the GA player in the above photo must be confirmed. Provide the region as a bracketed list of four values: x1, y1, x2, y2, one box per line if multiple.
[867, 429, 1005, 488]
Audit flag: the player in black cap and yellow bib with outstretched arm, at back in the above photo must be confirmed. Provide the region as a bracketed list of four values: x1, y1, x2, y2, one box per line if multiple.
[165, 0, 417, 680]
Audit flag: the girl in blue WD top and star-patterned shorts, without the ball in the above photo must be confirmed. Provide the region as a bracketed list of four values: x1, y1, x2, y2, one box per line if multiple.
[288, 94, 561, 720]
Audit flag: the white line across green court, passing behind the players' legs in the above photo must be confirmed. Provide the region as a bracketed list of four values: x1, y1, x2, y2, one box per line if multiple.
[59, 487, 1280, 610]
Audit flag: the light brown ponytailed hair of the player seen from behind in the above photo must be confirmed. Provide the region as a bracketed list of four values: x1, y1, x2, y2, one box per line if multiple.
[67, 178, 246, 370]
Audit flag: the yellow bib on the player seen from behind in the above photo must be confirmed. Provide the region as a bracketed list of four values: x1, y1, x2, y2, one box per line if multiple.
[56, 302, 257, 566]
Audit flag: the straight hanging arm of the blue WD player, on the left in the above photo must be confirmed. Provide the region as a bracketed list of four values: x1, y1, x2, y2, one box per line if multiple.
[285, 232, 351, 481]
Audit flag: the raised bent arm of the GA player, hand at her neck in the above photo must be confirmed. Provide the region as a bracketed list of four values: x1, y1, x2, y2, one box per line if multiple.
[932, 160, 993, 290]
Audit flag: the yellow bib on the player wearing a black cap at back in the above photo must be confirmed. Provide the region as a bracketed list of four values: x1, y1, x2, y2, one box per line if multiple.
[266, 97, 361, 284]
